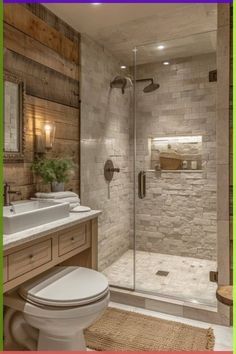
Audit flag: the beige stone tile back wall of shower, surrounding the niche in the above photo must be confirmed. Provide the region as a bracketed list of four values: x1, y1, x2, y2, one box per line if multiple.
[135, 53, 217, 260]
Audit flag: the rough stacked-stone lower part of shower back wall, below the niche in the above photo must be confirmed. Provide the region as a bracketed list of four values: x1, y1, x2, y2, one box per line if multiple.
[136, 171, 216, 259]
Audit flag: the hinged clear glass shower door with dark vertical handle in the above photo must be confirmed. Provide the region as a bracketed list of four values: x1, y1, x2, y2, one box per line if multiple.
[135, 31, 217, 306]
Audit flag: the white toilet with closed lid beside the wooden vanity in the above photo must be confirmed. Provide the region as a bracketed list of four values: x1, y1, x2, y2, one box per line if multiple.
[4, 267, 110, 351]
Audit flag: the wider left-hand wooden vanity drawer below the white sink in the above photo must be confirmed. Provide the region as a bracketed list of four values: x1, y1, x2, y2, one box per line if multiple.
[8, 239, 52, 280]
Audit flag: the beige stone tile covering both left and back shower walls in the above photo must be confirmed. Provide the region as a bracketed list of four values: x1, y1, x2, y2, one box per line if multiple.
[81, 36, 216, 270]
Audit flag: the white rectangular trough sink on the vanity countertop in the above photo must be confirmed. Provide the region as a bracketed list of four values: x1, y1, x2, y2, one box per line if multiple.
[3, 200, 70, 235]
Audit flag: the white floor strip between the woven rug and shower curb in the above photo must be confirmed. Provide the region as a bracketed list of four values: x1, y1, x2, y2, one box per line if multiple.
[110, 302, 233, 351]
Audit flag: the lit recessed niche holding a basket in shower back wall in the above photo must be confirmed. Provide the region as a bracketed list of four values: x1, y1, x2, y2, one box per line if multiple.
[149, 135, 203, 172]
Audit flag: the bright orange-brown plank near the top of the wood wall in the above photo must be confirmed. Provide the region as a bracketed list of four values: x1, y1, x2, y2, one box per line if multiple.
[4, 4, 80, 64]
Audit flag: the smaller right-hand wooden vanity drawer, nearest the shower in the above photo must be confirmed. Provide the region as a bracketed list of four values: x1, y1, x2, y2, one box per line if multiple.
[59, 224, 89, 256]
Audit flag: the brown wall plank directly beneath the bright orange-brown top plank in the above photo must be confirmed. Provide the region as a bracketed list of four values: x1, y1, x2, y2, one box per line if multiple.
[4, 24, 79, 80]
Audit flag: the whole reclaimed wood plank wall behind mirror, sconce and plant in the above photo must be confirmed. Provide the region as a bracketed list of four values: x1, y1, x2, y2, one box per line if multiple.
[4, 4, 80, 200]
